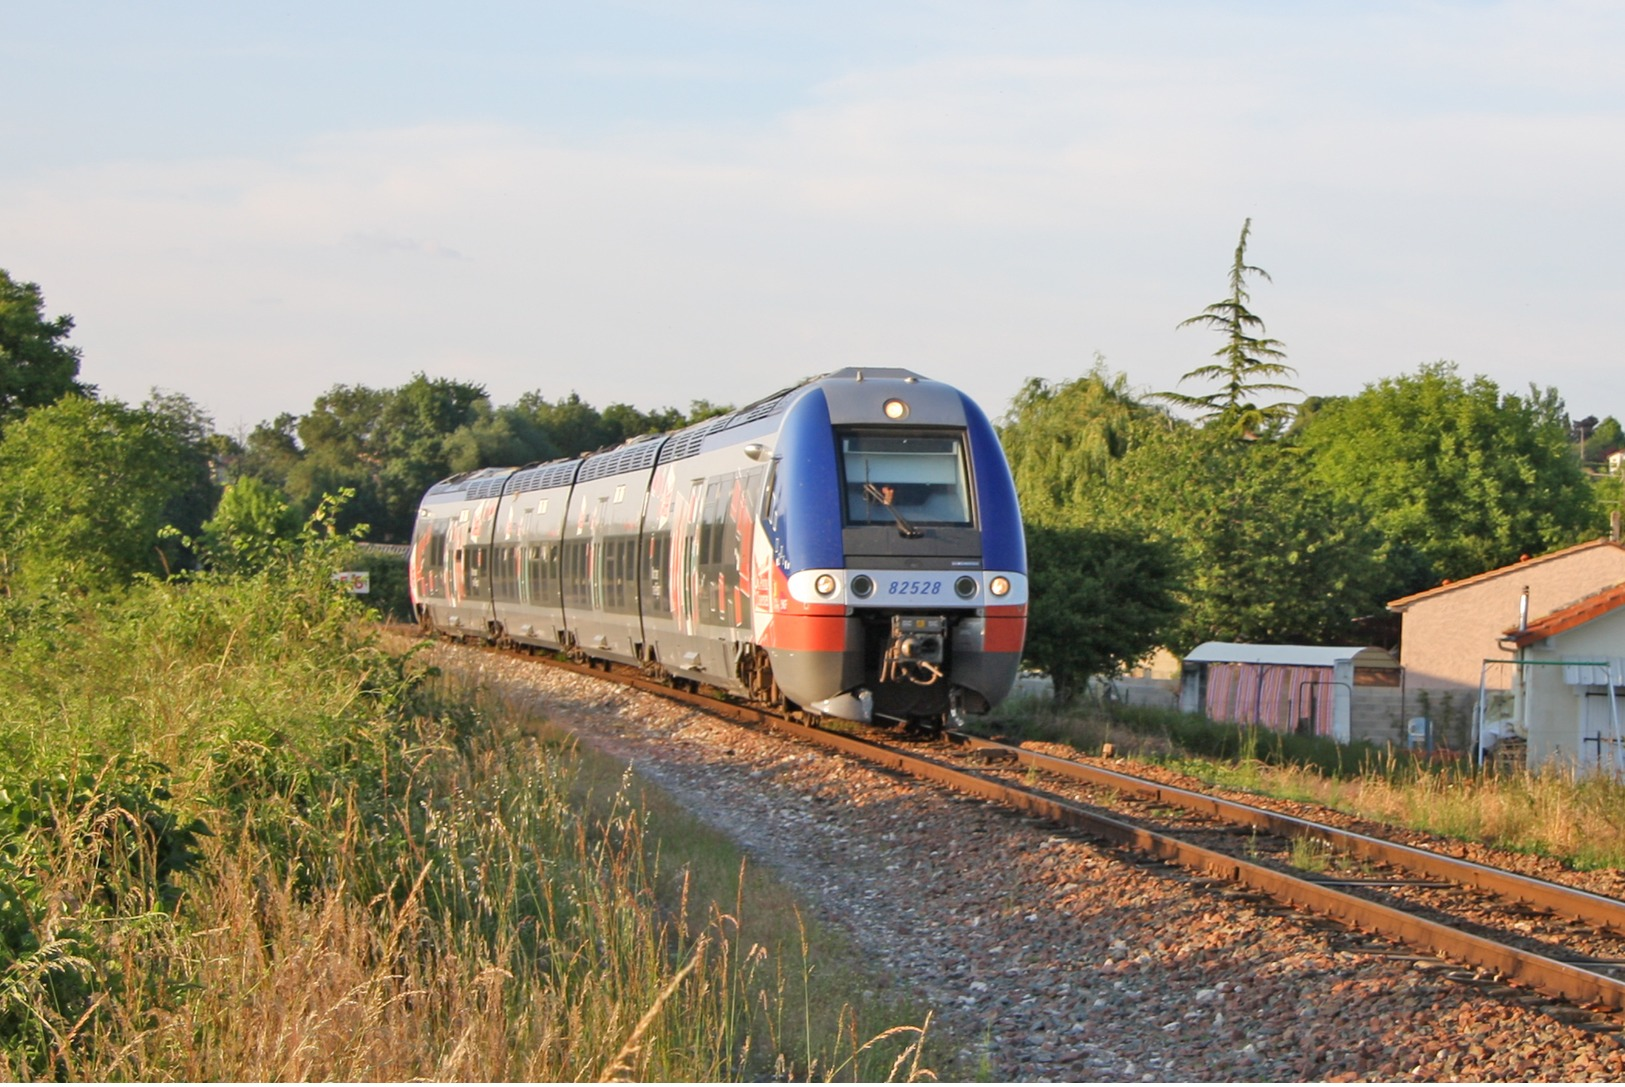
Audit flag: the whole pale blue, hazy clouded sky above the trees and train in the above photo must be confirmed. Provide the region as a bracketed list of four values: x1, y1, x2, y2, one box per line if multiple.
[0, 0, 1625, 434]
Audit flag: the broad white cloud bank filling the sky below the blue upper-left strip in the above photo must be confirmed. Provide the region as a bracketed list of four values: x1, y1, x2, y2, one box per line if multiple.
[0, 5, 1625, 426]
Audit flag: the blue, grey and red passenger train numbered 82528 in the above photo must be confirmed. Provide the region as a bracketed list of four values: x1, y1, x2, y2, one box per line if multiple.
[408, 367, 1029, 728]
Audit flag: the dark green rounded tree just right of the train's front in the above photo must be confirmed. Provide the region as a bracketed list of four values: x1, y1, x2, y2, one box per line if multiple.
[1025, 525, 1181, 700]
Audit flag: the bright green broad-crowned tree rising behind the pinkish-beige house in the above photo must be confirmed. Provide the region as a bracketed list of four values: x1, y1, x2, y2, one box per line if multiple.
[1298, 362, 1606, 596]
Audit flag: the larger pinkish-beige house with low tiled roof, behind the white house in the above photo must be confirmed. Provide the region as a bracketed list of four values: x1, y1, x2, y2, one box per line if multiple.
[1388, 539, 1625, 753]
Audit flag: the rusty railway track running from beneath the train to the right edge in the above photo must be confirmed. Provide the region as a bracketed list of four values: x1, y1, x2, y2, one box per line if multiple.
[500, 649, 1625, 1029]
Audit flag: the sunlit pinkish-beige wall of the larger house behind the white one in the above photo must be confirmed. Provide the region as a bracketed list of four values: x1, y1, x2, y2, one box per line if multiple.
[1399, 544, 1625, 692]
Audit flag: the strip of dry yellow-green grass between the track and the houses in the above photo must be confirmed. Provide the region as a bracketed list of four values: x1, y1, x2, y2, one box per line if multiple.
[999, 700, 1625, 869]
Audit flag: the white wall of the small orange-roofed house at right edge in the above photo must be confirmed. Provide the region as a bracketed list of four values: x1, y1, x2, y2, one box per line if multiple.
[1521, 609, 1625, 769]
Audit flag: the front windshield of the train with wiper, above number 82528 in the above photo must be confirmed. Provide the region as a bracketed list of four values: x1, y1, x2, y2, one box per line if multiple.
[840, 431, 972, 525]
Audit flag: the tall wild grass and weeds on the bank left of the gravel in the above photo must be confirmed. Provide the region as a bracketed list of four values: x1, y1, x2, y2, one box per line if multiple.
[0, 564, 923, 1081]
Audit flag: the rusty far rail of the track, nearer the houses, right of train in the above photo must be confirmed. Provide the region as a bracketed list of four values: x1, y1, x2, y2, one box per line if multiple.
[954, 733, 1625, 934]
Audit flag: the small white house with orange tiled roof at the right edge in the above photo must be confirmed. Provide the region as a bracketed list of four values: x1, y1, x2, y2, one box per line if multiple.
[1484, 585, 1625, 775]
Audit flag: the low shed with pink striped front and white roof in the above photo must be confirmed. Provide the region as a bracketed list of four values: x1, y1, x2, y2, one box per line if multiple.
[1180, 642, 1404, 744]
